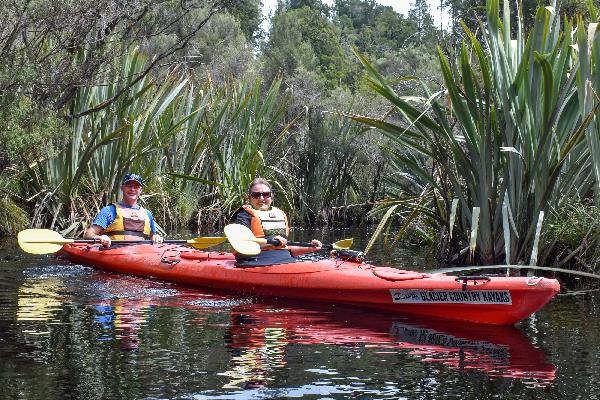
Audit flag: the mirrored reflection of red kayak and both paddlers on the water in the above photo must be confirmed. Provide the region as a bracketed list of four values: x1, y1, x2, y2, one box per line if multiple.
[82, 290, 556, 389]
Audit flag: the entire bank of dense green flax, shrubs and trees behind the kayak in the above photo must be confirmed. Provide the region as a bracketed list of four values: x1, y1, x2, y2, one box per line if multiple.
[0, 0, 600, 269]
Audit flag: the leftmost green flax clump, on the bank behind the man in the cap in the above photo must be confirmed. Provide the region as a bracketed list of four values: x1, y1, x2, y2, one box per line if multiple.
[27, 49, 185, 234]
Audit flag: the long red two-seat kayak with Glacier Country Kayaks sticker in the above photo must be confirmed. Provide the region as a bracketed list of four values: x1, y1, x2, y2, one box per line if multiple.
[62, 243, 560, 325]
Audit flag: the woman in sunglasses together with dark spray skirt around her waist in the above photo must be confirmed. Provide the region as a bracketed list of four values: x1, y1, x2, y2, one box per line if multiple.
[230, 177, 323, 265]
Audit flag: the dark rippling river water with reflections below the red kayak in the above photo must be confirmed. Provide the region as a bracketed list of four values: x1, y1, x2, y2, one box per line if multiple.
[0, 228, 600, 399]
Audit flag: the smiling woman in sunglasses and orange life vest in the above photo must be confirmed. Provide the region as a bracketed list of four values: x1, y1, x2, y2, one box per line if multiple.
[230, 178, 323, 256]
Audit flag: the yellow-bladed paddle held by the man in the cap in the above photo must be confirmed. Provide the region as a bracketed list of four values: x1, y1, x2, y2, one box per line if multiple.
[17, 229, 227, 254]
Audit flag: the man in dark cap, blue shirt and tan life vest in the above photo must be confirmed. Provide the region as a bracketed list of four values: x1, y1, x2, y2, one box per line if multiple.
[83, 174, 163, 247]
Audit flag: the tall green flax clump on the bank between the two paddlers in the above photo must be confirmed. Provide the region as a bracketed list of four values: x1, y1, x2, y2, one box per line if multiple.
[166, 79, 296, 224]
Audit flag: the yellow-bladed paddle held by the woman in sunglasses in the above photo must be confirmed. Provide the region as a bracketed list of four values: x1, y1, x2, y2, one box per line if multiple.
[225, 224, 354, 256]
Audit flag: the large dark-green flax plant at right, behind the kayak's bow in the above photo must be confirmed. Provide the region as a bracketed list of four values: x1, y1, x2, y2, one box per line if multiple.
[349, 0, 597, 264]
